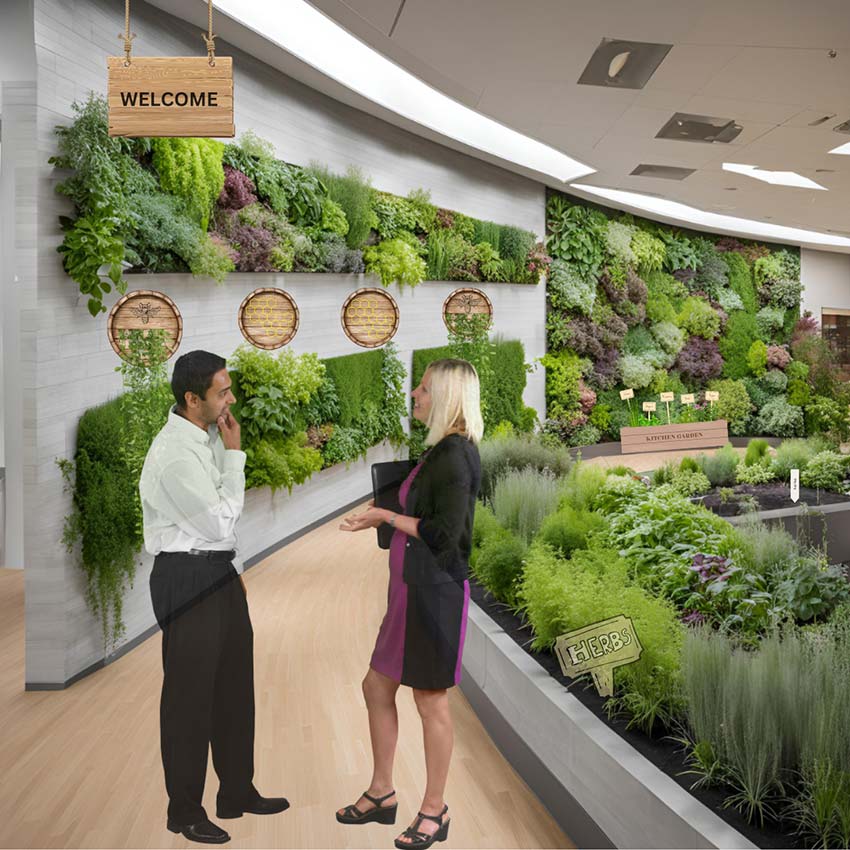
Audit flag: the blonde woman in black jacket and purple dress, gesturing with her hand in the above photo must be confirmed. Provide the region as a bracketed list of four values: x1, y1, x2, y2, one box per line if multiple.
[337, 360, 484, 850]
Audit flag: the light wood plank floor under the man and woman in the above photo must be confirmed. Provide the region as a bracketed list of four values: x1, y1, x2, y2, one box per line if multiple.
[0, 504, 574, 848]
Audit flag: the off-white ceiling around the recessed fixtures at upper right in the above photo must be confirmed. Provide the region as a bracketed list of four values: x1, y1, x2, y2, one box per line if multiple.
[310, 0, 850, 235]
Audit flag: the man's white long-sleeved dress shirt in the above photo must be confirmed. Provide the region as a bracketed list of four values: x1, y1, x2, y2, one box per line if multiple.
[139, 407, 245, 555]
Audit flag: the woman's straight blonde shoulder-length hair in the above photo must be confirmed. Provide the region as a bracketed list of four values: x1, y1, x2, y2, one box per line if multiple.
[425, 359, 484, 446]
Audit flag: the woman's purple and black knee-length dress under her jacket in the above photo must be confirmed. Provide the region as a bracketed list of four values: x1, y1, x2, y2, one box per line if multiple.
[370, 462, 469, 690]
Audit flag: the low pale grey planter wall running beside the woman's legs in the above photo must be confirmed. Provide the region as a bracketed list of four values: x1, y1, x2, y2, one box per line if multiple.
[461, 604, 756, 848]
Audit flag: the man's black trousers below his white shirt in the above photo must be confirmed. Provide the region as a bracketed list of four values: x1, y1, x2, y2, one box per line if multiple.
[150, 552, 257, 827]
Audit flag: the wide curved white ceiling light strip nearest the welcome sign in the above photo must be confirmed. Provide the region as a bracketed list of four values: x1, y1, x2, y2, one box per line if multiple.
[216, 0, 596, 182]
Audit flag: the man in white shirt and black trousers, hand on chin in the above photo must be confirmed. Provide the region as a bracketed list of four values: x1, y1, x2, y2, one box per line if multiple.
[139, 351, 289, 844]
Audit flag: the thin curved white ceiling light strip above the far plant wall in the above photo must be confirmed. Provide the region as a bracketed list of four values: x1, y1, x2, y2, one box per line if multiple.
[570, 183, 850, 251]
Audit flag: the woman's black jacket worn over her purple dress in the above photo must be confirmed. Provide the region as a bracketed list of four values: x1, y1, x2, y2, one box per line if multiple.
[403, 434, 481, 584]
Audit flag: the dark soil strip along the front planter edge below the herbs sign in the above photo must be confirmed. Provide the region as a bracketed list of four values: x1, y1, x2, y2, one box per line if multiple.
[469, 580, 803, 848]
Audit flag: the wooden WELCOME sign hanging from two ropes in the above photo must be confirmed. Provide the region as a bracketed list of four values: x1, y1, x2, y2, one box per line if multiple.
[107, 0, 236, 139]
